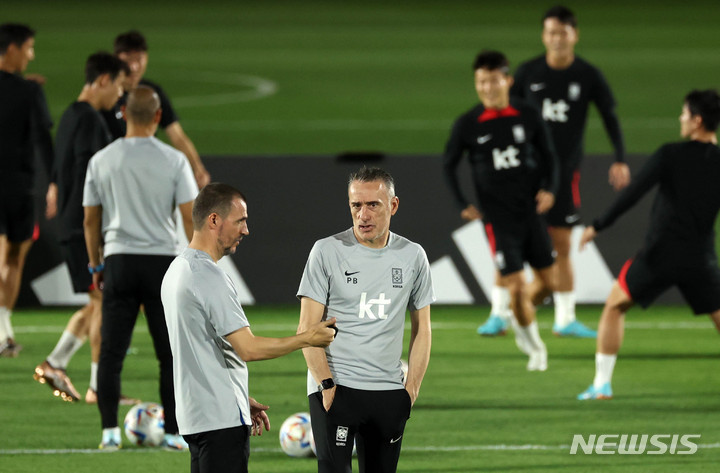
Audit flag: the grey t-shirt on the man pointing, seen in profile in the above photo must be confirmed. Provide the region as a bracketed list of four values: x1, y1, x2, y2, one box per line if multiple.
[161, 248, 252, 435]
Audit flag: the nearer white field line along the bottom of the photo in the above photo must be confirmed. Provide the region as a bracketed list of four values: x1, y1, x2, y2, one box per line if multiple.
[0, 443, 720, 455]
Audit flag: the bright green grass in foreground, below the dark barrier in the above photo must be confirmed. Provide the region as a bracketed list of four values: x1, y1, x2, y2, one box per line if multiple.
[0, 307, 720, 473]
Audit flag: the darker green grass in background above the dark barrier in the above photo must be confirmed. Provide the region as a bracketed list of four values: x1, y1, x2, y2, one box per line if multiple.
[2, 0, 720, 155]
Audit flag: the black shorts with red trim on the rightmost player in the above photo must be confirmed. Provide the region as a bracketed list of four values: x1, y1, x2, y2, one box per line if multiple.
[618, 247, 720, 315]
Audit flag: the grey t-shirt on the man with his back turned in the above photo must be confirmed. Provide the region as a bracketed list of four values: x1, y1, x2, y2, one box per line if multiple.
[83, 137, 198, 257]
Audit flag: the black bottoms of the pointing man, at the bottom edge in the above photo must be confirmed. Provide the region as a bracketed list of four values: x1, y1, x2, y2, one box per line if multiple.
[183, 425, 250, 473]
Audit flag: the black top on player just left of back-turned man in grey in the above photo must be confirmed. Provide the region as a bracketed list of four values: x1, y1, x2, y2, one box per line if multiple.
[53, 102, 111, 241]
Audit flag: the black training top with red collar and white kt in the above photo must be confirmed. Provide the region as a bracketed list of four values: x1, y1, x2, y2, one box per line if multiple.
[443, 99, 558, 222]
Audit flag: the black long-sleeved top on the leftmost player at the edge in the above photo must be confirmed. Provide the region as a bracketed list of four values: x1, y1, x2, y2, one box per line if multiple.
[0, 71, 53, 195]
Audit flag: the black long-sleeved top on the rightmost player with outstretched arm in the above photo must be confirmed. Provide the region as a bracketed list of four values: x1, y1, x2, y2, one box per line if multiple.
[593, 141, 720, 257]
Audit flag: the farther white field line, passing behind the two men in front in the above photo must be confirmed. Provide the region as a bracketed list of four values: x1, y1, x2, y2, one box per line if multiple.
[14, 319, 713, 333]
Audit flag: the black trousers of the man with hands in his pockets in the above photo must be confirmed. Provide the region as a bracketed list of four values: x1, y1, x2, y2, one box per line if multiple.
[308, 386, 411, 473]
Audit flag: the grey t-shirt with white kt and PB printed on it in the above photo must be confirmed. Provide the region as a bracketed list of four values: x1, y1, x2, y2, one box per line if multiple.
[297, 228, 435, 394]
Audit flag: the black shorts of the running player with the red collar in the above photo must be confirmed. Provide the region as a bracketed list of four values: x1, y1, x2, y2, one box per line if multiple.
[485, 214, 555, 276]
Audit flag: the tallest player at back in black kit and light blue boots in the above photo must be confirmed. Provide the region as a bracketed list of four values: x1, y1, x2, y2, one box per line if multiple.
[479, 6, 630, 338]
